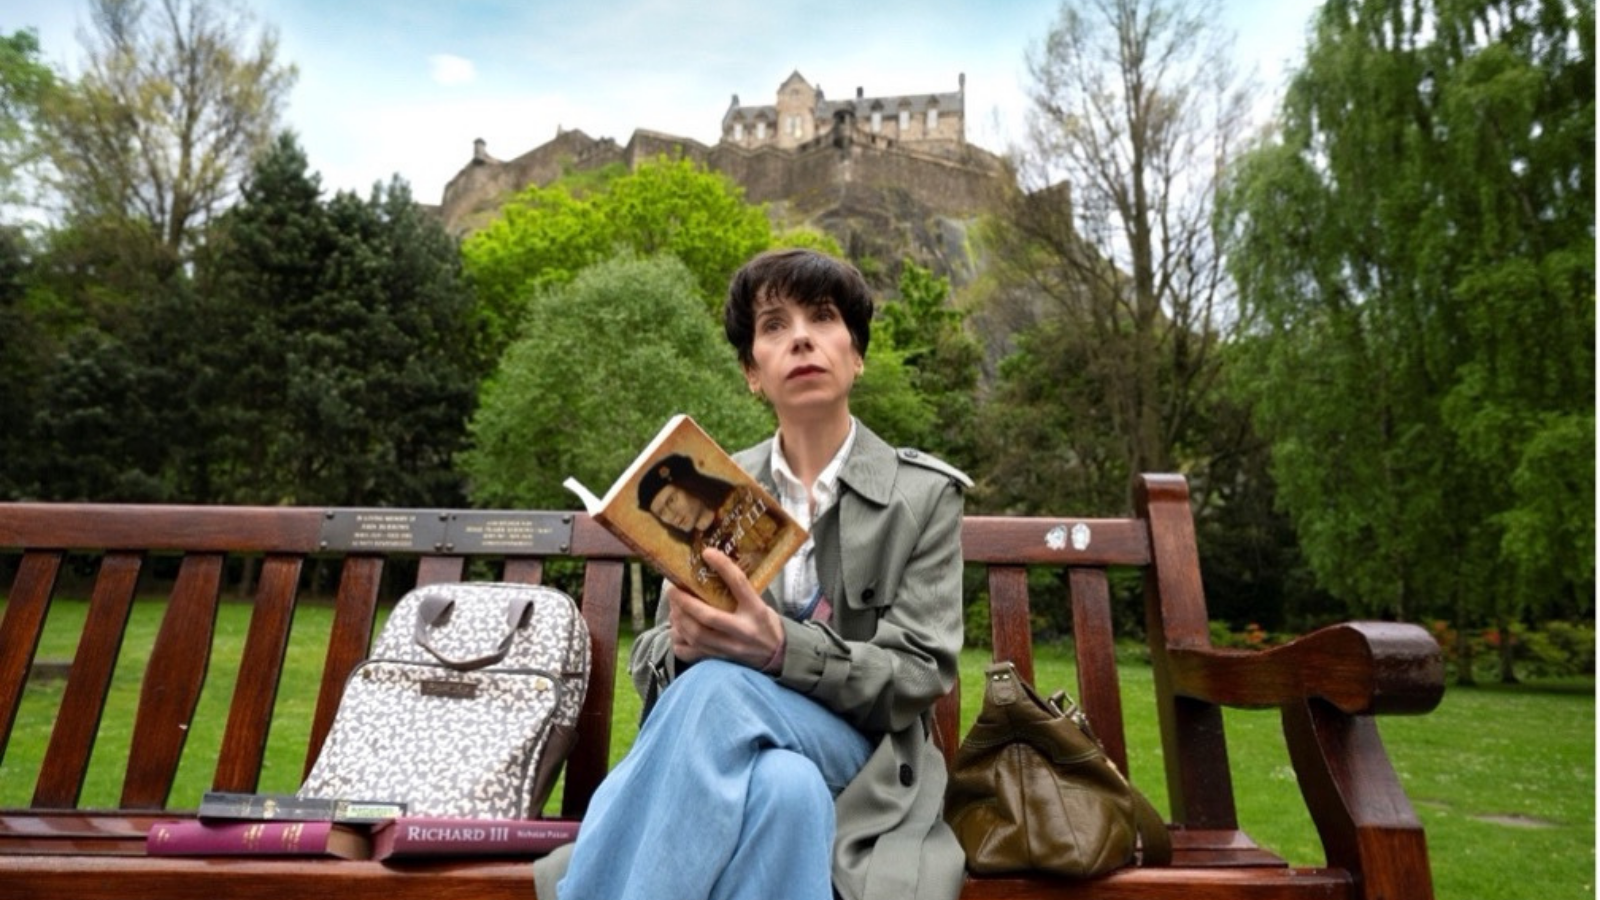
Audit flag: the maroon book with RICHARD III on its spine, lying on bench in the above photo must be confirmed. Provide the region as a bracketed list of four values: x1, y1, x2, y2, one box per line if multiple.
[373, 815, 578, 860]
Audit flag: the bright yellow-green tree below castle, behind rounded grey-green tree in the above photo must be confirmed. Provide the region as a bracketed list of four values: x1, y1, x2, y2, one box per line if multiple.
[462, 157, 773, 351]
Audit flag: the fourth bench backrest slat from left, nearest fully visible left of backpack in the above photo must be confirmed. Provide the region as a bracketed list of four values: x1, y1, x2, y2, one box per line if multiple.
[214, 554, 304, 793]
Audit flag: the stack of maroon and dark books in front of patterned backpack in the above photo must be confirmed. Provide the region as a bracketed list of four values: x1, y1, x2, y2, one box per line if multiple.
[144, 791, 578, 862]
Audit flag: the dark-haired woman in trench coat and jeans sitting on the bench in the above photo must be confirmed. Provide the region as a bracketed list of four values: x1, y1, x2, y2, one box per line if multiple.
[534, 250, 970, 900]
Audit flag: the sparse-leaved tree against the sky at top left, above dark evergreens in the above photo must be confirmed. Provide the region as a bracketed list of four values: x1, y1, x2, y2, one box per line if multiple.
[42, 0, 296, 263]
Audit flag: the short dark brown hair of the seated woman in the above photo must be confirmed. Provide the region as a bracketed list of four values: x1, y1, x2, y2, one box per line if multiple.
[722, 248, 872, 365]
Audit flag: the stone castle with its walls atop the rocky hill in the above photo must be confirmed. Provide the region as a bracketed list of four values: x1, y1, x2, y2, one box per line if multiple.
[440, 72, 1006, 234]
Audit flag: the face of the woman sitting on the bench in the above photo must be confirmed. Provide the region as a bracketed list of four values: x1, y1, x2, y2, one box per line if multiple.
[744, 298, 862, 415]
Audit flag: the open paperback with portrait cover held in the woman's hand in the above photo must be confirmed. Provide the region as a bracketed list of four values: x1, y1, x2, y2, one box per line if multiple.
[565, 413, 806, 610]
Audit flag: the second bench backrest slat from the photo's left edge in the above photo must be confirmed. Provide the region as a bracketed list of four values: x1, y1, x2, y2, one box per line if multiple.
[34, 552, 144, 809]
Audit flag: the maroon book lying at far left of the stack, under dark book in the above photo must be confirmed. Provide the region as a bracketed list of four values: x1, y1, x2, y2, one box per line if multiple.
[144, 820, 371, 860]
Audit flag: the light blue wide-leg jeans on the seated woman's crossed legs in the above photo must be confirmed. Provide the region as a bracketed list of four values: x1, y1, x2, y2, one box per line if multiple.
[558, 660, 872, 900]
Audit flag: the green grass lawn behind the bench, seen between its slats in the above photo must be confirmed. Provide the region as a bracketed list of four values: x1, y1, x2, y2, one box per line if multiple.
[0, 602, 1595, 900]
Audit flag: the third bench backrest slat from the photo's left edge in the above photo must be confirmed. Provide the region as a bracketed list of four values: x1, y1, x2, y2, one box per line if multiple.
[122, 552, 222, 809]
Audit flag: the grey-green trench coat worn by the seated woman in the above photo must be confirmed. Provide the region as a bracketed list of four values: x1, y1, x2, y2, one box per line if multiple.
[534, 426, 971, 900]
